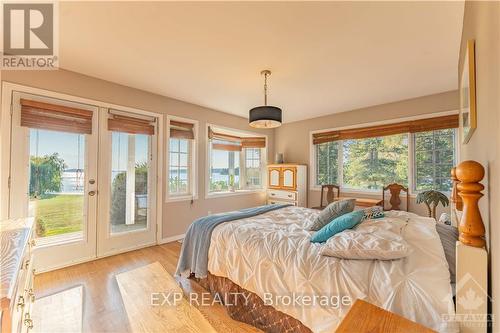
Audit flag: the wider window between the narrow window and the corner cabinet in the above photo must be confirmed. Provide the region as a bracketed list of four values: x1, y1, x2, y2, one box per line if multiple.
[208, 127, 266, 193]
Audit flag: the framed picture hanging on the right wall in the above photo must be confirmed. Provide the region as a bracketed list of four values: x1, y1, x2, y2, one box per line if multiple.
[460, 40, 477, 144]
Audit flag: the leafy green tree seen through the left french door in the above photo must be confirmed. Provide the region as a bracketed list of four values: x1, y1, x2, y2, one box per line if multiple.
[29, 153, 66, 198]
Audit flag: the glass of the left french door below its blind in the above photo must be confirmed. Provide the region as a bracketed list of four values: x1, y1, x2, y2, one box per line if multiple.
[29, 129, 86, 238]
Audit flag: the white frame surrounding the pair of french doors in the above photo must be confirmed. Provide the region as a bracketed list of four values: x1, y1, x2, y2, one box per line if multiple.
[0, 81, 164, 272]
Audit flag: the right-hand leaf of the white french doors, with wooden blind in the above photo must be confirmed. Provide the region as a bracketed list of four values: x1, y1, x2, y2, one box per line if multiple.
[97, 110, 157, 256]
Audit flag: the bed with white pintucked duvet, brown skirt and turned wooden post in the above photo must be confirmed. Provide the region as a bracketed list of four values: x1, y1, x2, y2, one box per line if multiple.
[176, 161, 491, 333]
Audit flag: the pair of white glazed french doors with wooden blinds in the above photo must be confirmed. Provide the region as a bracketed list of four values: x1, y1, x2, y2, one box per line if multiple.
[8, 91, 157, 271]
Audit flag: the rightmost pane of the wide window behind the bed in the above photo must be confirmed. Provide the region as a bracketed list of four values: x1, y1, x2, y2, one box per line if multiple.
[413, 129, 456, 191]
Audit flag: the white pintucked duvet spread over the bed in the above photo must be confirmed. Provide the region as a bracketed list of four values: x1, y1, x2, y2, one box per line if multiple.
[208, 207, 458, 332]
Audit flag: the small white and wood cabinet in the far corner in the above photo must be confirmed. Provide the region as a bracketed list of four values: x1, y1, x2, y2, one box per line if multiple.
[267, 163, 307, 207]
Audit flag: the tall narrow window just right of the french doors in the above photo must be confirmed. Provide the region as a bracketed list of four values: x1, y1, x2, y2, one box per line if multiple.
[167, 116, 196, 200]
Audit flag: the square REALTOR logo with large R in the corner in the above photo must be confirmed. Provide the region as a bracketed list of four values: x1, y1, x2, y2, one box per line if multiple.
[2, 2, 58, 70]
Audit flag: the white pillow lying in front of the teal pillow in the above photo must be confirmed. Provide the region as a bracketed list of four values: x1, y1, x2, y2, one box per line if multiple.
[320, 229, 409, 260]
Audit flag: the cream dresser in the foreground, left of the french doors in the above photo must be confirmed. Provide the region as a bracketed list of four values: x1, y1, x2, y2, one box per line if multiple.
[0, 218, 35, 333]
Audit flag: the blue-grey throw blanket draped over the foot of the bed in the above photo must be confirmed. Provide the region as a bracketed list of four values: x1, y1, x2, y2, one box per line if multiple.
[175, 204, 290, 278]
